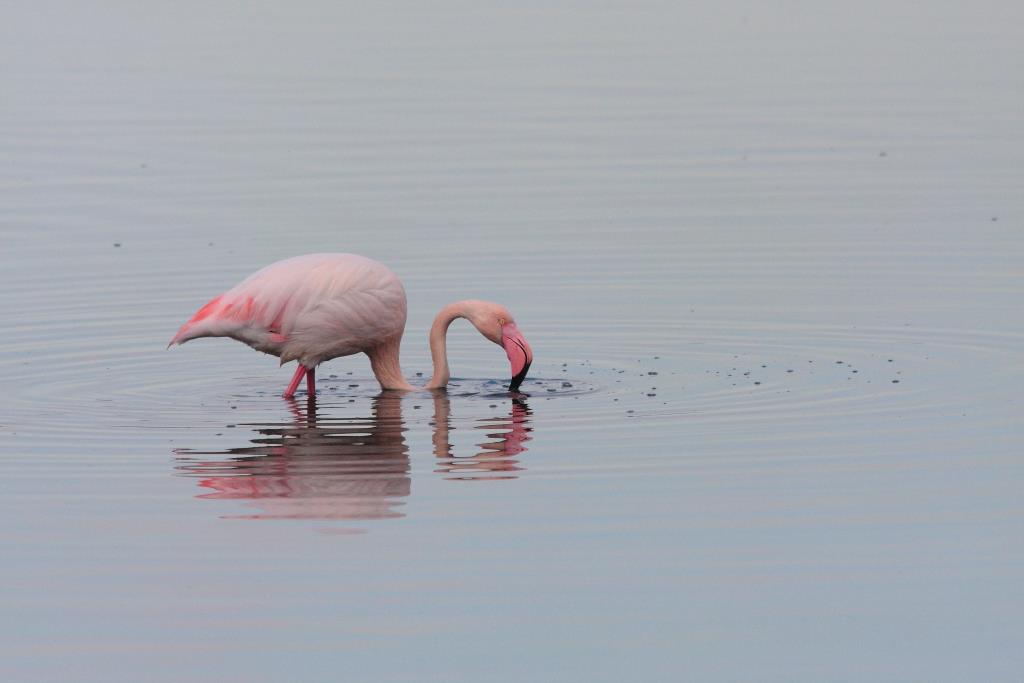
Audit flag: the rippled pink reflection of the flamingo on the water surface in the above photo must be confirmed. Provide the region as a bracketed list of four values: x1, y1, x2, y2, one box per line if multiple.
[175, 392, 531, 520]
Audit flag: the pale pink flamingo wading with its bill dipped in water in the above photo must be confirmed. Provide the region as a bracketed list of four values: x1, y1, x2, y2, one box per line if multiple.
[168, 254, 534, 398]
